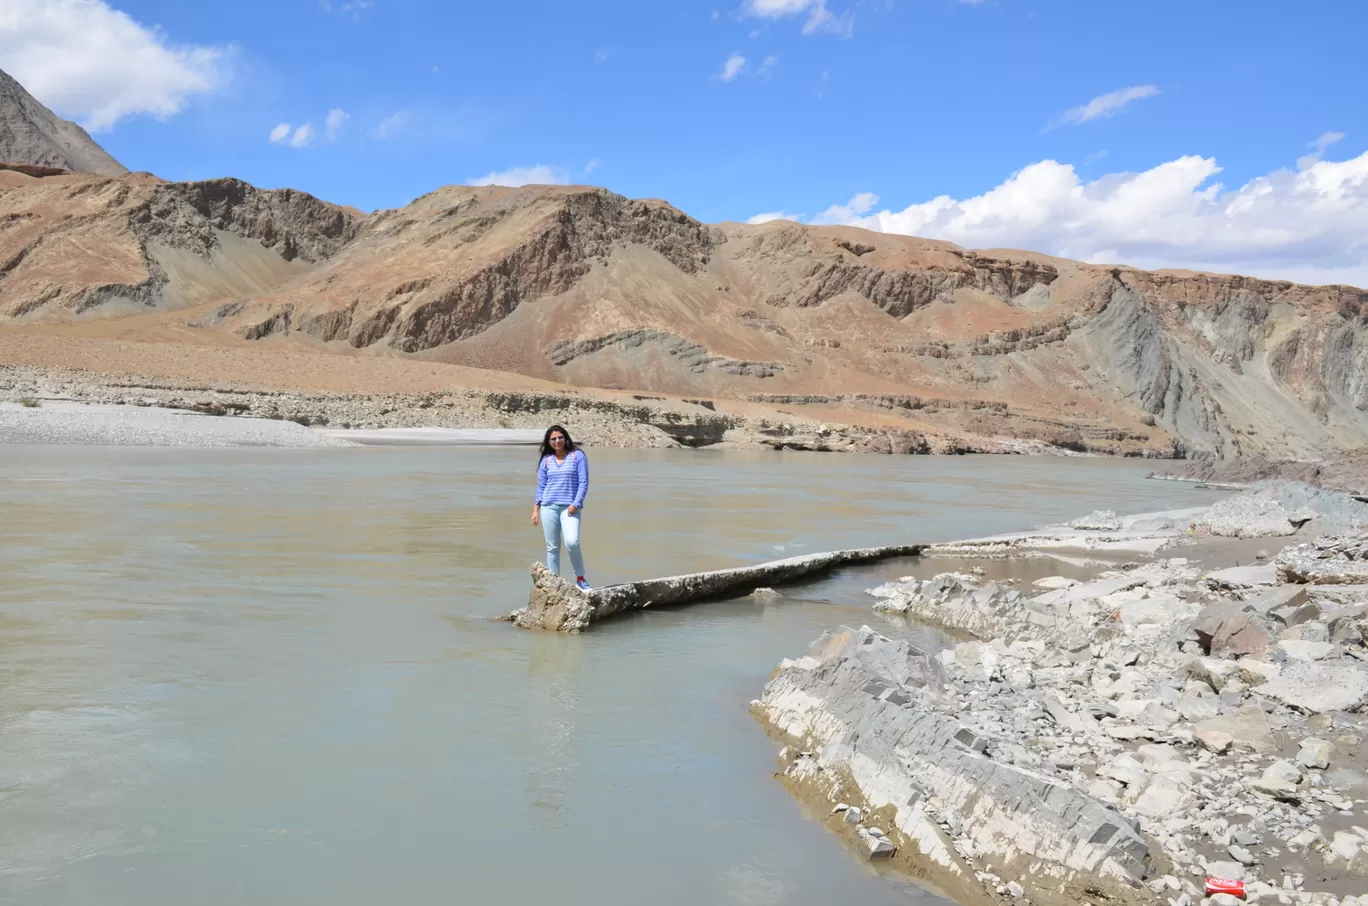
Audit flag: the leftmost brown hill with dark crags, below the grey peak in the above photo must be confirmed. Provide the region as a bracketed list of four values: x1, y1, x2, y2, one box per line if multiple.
[0, 170, 361, 322]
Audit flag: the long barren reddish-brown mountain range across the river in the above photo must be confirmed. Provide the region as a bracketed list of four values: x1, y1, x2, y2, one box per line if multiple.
[0, 166, 1368, 457]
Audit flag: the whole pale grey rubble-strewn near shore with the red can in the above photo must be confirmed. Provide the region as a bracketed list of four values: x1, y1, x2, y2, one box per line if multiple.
[752, 482, 1368, 906]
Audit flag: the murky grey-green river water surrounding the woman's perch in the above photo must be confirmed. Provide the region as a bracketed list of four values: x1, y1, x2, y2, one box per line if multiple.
[0, 446, 1231, 906]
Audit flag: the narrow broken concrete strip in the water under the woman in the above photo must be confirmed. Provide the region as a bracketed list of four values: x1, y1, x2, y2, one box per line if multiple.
[503, 545, 926, 632]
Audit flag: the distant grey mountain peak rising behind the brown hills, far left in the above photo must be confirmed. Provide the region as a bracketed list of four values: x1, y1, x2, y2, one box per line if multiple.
[0, 71, 129, 177]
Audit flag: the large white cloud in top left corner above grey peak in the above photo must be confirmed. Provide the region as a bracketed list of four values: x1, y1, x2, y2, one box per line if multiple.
[0, 0, 233, 131]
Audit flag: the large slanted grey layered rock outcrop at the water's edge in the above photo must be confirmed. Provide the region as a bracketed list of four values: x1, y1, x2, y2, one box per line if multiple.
[754, 627, 1150, 902]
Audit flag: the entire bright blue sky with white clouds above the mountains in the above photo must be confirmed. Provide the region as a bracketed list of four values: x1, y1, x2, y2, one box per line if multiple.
[0, 0, 1368, 283]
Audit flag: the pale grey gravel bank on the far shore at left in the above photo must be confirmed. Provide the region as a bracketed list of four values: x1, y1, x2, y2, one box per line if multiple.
[0, 402, 356, 446]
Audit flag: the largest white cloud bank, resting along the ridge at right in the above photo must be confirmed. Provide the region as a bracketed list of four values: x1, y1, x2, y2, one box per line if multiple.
[777, 145, 1368, 286]
